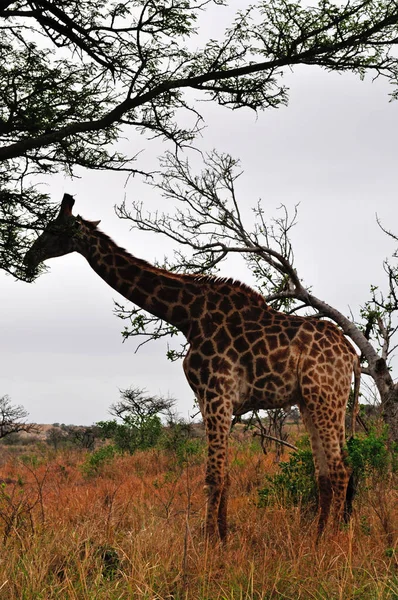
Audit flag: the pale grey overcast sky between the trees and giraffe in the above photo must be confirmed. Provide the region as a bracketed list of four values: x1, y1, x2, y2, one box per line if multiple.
[0, 47, 398, 424]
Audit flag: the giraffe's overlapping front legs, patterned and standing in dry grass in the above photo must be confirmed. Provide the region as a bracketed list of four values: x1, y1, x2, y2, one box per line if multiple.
[204, 397, 232, 541]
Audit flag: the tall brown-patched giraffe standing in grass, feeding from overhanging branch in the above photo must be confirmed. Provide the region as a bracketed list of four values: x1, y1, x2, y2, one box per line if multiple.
[25, 194, 359, 541]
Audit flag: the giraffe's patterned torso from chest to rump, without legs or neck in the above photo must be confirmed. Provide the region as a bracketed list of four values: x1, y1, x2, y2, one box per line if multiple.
[184, 295, 355, 414]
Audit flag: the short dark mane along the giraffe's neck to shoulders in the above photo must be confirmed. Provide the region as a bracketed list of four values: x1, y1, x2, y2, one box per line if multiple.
[80, 217, 266, 306]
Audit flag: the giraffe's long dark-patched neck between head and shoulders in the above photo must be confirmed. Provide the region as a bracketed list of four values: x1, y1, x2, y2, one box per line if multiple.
[78, 221, 199, 335]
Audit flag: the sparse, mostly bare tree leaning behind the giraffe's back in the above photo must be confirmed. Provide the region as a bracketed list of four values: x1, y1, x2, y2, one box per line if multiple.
[116, 152, 398, 441]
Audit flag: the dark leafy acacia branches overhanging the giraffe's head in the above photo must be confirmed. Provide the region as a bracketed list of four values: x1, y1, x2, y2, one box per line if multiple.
[0, 0, 398, 278]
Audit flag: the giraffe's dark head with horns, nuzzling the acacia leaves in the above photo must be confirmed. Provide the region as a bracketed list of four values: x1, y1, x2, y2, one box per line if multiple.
[24, 194, 99, 278]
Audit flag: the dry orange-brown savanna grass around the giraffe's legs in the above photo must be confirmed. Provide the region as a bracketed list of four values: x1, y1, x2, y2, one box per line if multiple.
[0, 428, 398, 600]
